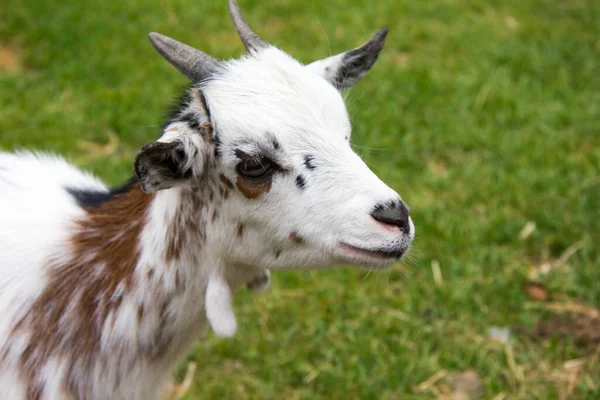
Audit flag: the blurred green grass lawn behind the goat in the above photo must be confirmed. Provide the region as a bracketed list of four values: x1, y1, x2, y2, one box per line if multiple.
[0, 0, 600, 400]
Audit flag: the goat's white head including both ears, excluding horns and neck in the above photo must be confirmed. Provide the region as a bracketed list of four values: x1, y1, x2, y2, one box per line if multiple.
[136, 3, 415, 269]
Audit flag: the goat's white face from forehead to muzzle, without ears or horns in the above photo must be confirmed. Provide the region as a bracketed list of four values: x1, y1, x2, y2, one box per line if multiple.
[204, 48, 414, 268]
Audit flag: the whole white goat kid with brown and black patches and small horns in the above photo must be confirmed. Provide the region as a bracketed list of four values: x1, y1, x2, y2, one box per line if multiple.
[0, 0, 415, 400]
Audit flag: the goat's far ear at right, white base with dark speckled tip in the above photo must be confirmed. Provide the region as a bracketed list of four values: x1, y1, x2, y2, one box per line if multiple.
[306, 28, 388, 90]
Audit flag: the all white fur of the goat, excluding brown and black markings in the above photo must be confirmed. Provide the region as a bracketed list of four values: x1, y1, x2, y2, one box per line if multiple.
[0, 25, 414, 400]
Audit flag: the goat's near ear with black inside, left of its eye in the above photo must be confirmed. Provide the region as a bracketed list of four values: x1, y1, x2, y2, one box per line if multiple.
[134, 139, 202, 193]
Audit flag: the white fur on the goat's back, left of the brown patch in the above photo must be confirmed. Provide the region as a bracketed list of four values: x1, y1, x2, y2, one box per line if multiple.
[0, 153, 107, 399]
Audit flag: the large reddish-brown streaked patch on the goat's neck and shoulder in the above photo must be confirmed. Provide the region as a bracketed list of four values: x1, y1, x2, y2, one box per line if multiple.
[15, 182, 154, 399]
